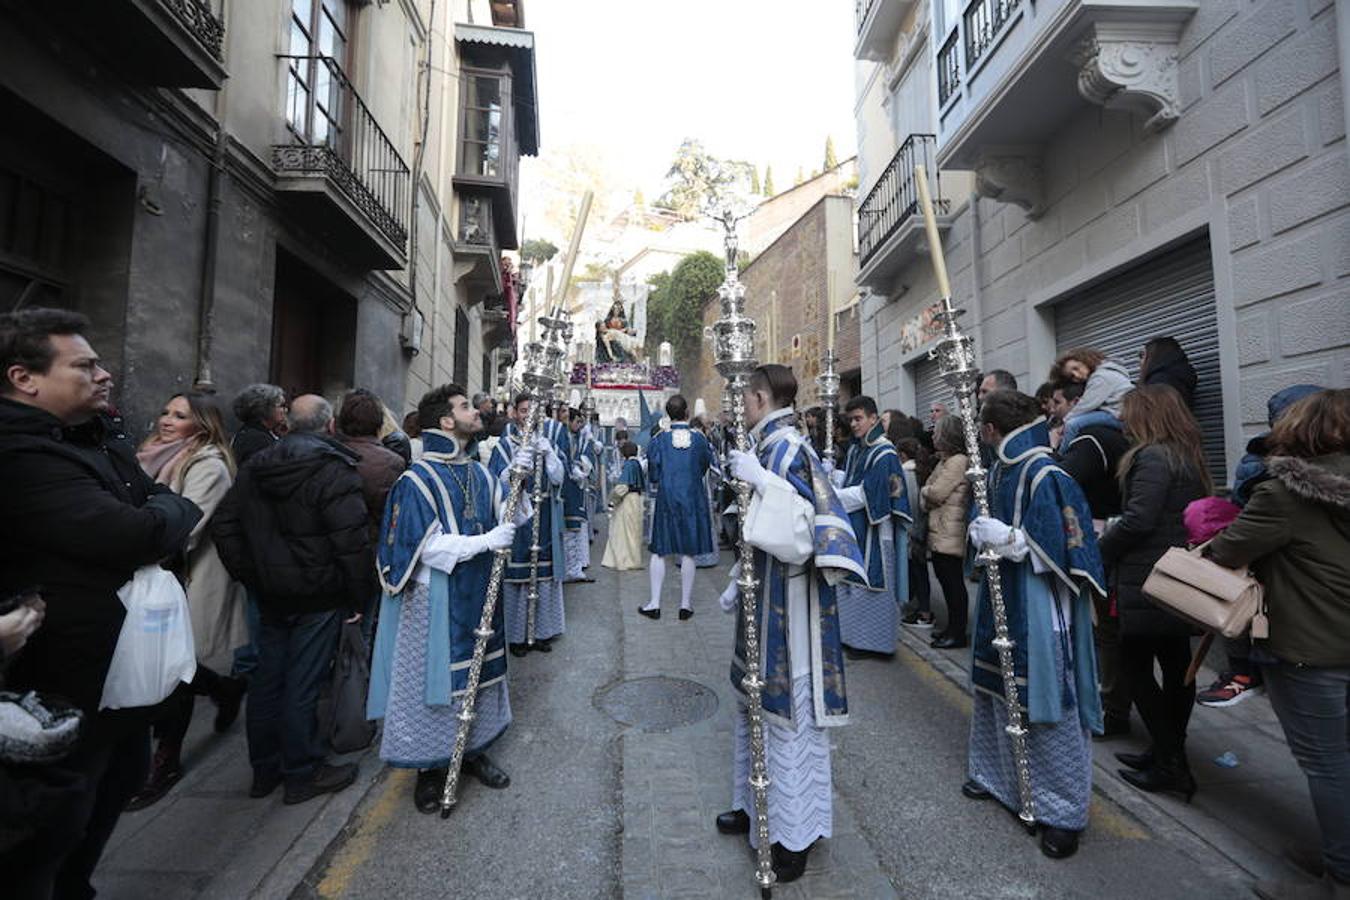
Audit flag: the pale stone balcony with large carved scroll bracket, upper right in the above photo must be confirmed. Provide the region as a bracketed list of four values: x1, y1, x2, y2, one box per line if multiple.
[936, 0, 1199, 216]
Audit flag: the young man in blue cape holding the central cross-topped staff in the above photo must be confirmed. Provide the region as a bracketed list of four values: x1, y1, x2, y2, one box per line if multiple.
[717, 364, 863, 882]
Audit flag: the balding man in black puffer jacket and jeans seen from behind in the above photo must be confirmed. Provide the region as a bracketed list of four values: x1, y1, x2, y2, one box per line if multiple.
[211, 394, 377, 803]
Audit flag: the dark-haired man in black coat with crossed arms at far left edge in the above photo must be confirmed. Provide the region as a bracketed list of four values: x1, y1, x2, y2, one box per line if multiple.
[0, 308, 201, 897]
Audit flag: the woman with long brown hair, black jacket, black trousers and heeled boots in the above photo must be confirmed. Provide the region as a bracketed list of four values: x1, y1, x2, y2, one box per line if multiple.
[1099, 385, 1211, 800]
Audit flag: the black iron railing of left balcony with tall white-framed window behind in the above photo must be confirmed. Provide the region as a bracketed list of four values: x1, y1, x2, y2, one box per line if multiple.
[273, 55, 410, 248]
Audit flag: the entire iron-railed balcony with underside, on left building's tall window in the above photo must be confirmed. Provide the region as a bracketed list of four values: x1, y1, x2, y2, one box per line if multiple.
[271, 57, 410, 269]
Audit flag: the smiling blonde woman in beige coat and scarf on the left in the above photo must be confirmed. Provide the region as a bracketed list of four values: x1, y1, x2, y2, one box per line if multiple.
[127, 393, 248, 810]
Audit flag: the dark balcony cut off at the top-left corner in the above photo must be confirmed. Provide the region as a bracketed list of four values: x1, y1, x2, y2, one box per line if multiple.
[42, 0, 225, 90]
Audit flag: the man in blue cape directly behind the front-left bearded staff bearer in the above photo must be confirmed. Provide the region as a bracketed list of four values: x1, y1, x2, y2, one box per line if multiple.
[487, 394, 568, 656]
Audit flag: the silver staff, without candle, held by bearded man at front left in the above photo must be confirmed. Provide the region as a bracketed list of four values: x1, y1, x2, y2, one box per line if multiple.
[440, 317, 560, 819]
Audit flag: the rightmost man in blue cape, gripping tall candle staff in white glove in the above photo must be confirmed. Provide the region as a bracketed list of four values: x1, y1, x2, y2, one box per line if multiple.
[961, 390, 1104, 860]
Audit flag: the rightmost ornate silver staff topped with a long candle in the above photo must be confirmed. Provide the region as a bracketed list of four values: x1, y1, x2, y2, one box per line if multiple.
[914, 166, 1035, 831]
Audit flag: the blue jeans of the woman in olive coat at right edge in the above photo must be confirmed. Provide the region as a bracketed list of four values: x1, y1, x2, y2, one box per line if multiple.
[1262, 663, 1350, 882]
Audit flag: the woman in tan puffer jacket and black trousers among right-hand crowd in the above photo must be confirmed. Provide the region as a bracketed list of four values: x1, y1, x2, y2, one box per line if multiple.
[921, 416, 971, 650]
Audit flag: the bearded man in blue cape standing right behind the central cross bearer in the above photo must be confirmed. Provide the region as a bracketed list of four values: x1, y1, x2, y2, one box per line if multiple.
[838, 397, 913, 658]
